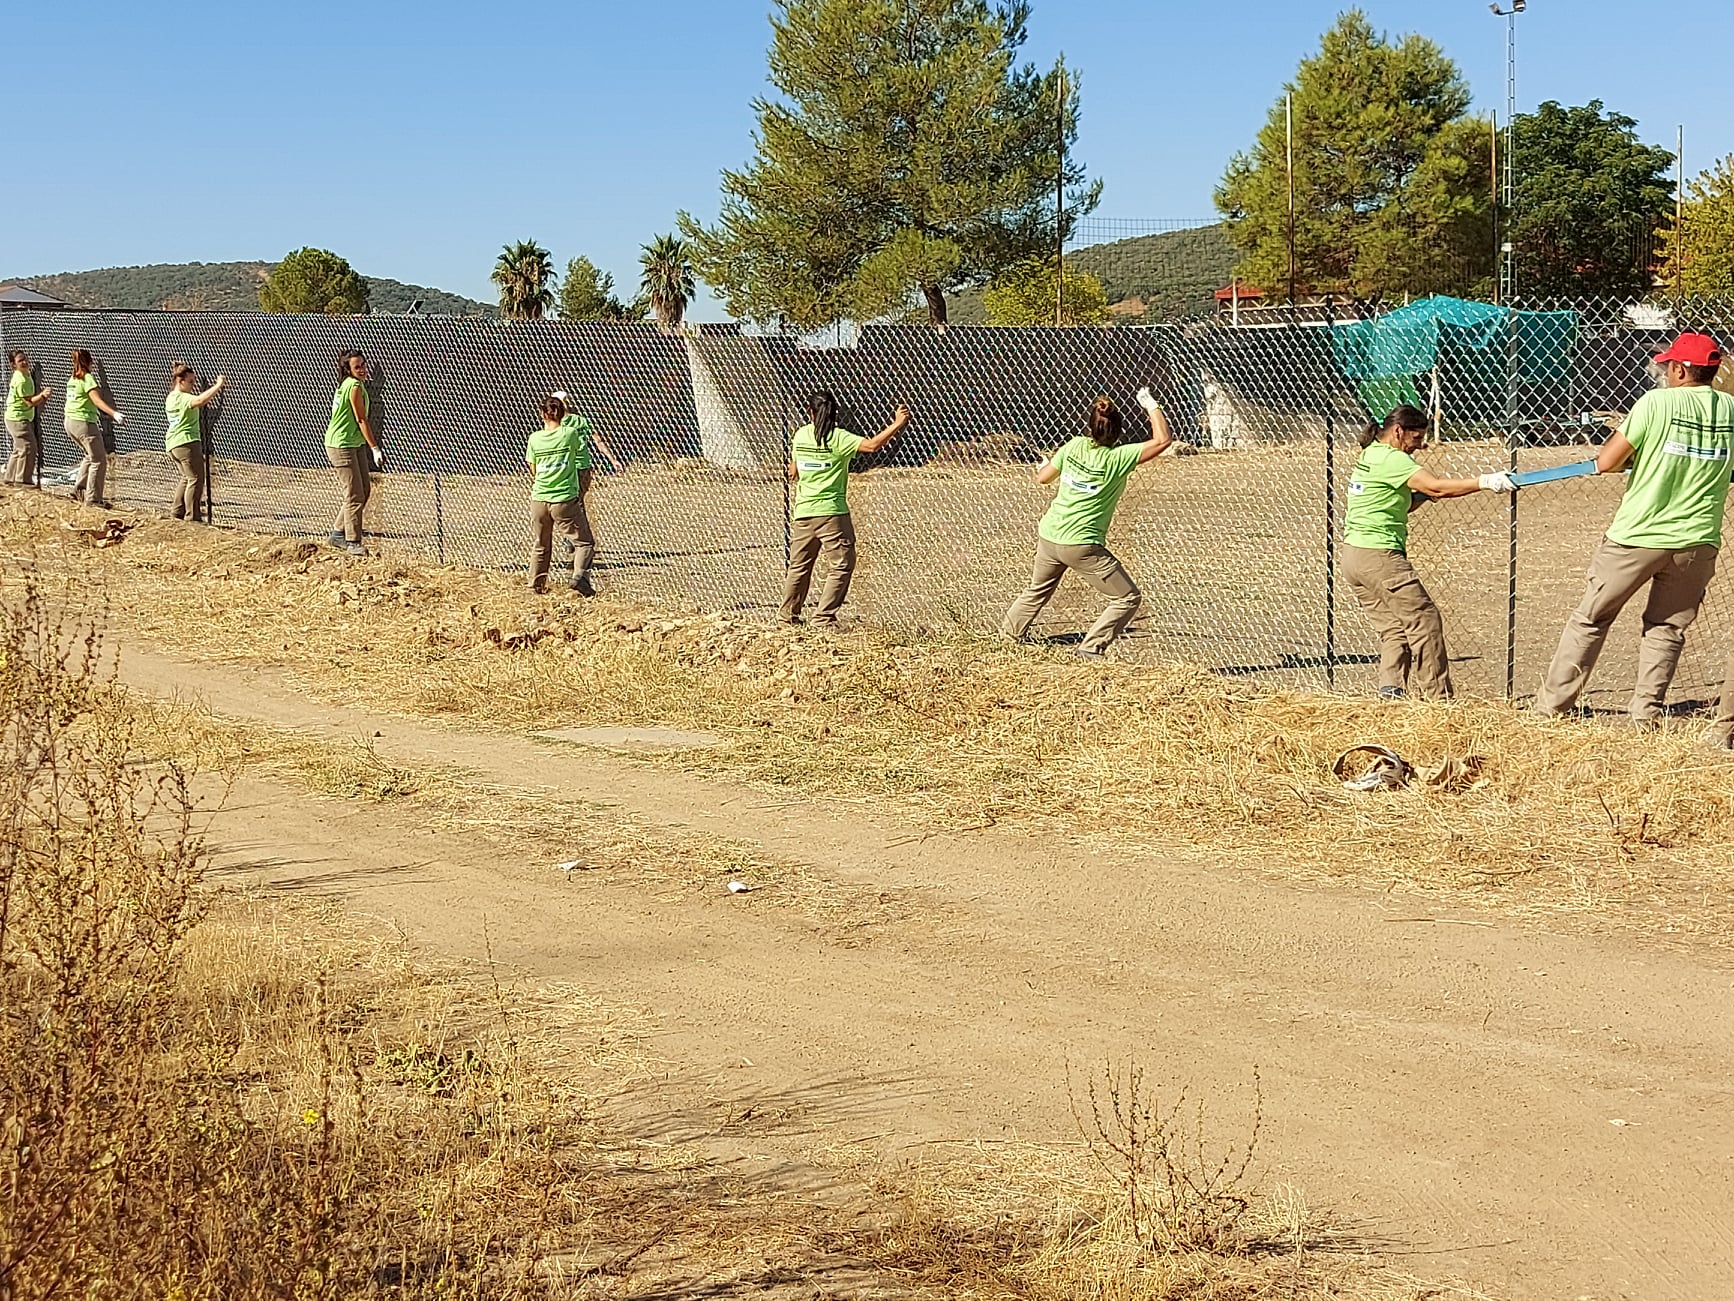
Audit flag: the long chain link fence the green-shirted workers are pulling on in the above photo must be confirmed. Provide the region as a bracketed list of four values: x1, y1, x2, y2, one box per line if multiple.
[0, 302, 1734, 708]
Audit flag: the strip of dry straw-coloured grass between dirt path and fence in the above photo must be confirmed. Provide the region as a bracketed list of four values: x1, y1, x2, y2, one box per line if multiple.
[0, 498, 1734, 944]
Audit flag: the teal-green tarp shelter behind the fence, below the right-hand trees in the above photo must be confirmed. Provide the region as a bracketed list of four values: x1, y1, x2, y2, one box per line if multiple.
[1330, 297, 1578, 420]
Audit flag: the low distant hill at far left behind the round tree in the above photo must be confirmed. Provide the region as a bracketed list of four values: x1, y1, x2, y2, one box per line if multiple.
[12, 262, 498, 316]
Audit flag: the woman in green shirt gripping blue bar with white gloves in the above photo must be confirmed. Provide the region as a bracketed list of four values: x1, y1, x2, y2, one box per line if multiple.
[1342, 406, 1517, 701]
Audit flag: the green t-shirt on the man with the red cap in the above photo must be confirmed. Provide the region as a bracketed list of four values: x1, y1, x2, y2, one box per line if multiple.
[1607, 385, 1734, 552]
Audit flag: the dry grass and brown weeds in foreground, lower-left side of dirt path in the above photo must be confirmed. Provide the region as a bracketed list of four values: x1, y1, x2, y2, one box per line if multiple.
[0, 562, 1491, 1301]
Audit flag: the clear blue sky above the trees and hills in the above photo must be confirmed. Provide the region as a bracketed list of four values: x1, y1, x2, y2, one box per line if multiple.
[10, 0, 1734, 316]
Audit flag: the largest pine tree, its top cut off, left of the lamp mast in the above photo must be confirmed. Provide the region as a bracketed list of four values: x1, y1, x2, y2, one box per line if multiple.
[680, 0, 1099, 328]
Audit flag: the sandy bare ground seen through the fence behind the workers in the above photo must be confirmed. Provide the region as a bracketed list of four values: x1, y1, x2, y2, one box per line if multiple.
[61, 442, 1734, 709]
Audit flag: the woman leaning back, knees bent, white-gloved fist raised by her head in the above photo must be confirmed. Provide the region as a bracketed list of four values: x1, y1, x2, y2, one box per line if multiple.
[999, 389, 1174, 659]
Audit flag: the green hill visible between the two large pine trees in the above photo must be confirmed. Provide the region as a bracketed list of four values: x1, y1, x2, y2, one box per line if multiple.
[950, 222, 1240, 324]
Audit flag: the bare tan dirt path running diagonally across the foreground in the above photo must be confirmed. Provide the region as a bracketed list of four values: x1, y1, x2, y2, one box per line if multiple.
[123, 649, 1734, 1301]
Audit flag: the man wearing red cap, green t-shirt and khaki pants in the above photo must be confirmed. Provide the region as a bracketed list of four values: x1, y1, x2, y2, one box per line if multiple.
[1535, 333, 1734, 723]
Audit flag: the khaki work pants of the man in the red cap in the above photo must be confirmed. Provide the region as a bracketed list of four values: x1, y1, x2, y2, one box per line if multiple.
[1535, 538, 1725, 723]
